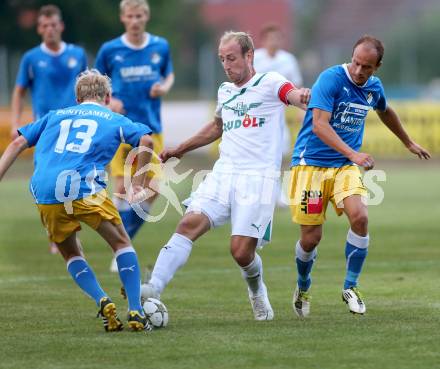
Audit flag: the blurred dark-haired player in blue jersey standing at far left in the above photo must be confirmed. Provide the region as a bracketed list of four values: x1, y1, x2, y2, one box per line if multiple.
[11, 5, 87, 253]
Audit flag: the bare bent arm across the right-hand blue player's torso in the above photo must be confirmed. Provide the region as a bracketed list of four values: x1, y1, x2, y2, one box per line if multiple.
[313, 108, 374, 170]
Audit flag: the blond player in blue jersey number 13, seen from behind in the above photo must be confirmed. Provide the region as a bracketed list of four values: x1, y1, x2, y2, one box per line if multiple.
[0, 70, 153, 331]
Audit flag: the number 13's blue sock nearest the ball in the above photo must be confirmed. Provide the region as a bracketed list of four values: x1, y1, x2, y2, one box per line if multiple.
[115, 246, 143, 315]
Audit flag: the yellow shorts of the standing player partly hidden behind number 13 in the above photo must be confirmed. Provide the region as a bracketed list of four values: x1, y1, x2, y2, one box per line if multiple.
[110, 133, 163, 179]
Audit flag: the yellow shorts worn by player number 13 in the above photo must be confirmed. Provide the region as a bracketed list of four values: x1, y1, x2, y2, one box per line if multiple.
[37, 190, 122, 243]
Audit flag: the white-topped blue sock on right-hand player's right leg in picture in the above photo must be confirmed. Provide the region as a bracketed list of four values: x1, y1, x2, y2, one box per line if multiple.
[344, 229, 369, 289]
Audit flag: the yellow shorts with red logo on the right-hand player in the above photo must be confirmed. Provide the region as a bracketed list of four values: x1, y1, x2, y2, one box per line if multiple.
[289, 165, 367, 225]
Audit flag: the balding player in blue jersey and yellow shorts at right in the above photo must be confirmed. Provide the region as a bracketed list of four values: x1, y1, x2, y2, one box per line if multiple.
[290, 35, 430, 316]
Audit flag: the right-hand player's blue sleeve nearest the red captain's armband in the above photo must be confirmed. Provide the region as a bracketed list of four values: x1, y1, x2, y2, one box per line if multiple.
[309, 70, 339, 112]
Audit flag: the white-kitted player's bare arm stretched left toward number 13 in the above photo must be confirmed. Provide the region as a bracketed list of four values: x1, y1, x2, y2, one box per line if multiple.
[159, 117, 223, 163]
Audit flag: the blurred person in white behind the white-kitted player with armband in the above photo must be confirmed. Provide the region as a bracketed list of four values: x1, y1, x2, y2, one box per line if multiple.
[254, 24, 304, 207]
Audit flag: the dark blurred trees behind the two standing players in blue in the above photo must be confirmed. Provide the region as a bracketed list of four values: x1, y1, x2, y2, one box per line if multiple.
[0, 0, 210, 96]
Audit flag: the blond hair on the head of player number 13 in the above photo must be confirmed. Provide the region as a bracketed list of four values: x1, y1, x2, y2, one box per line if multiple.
[75, 69, 112, 103]
